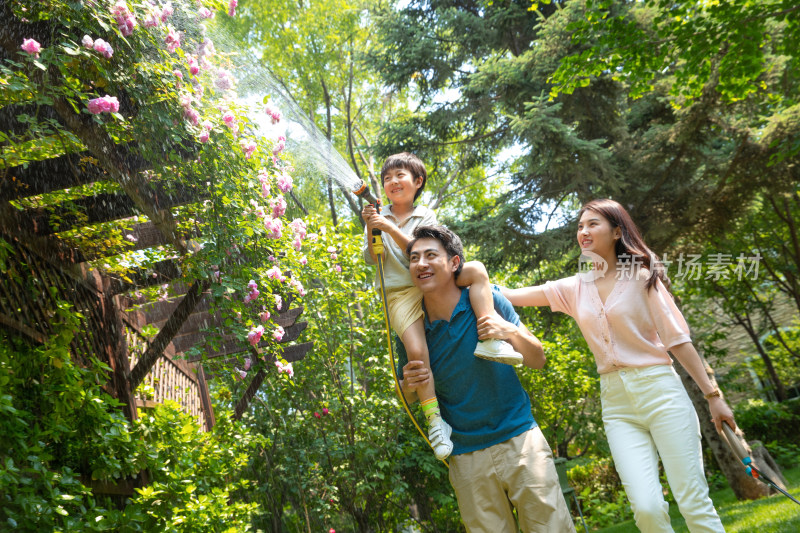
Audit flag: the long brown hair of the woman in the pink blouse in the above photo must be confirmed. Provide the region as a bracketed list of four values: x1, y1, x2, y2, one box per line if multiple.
[578, 198, 670, 292]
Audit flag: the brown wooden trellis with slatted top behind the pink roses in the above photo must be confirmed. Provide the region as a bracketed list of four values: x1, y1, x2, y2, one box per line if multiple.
[0, 125, 312, 428]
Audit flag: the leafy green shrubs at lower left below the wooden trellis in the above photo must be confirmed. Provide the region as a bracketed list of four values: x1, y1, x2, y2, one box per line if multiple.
[0, 303, 257, 531]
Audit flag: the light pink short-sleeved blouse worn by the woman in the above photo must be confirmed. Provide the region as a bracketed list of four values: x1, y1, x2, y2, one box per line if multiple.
[544, 269, 691, 374]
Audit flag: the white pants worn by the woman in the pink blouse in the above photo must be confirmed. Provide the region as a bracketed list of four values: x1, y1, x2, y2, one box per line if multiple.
[600, 365, 725, 533]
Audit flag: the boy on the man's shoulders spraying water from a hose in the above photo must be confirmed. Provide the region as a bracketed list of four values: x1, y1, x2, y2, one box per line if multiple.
[361, 152, 522, 459]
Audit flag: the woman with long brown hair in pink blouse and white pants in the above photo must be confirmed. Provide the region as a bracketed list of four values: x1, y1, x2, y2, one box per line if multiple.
[503, 200, 735, 533]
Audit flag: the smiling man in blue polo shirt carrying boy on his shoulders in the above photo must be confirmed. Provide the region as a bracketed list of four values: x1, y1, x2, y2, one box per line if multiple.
[398, 226, 575, 533]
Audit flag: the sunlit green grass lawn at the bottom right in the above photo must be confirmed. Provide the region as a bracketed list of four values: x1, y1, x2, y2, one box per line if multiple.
[596, 467, 800, 533]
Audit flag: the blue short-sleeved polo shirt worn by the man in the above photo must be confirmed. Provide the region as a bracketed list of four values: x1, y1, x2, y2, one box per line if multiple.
[397, 287, 536, 455]
